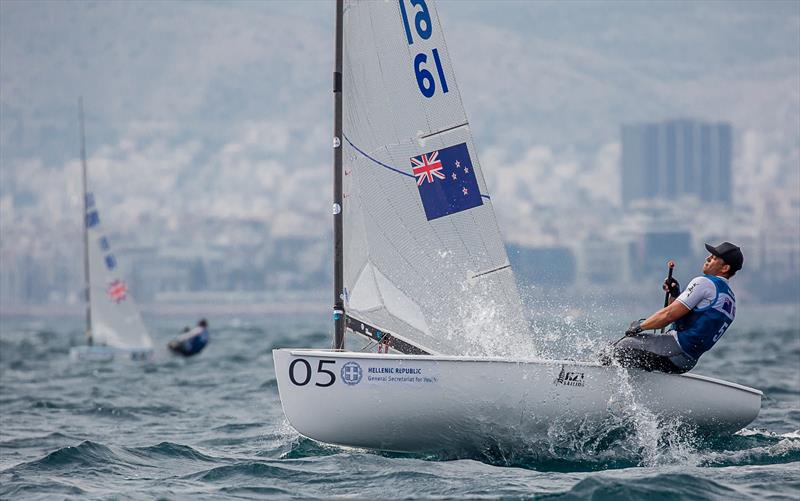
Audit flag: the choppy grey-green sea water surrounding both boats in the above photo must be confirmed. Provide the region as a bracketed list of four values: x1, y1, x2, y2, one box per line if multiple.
[0, 311, 800, 499]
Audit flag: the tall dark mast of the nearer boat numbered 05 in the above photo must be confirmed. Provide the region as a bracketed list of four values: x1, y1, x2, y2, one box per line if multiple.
[333, 0, 345, 350]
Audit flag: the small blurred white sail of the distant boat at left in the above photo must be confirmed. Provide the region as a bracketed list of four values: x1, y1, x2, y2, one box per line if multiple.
[85, 193, 153, 348]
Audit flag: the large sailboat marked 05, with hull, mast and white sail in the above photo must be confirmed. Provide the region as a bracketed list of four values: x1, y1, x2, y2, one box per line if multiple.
[273, 0, 762, 452]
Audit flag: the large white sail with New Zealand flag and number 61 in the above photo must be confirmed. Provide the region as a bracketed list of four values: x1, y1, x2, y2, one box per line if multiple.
[342, 0, 525, 355]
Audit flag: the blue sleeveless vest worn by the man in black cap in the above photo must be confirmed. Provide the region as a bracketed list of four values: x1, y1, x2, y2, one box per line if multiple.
[674, 275, 736, 360]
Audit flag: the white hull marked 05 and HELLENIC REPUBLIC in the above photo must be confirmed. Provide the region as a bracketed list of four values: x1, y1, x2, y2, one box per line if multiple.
[272, 349, 762, 452]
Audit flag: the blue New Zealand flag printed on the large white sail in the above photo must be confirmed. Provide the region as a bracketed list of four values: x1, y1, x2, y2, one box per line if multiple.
[411, 143, 483, 221]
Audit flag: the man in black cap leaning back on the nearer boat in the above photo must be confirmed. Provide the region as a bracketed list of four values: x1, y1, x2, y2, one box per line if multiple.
[606, 242, 744, 374]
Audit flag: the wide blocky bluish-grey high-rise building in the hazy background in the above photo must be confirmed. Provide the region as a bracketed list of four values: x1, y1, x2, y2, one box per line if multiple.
[621, 119, 733, 206]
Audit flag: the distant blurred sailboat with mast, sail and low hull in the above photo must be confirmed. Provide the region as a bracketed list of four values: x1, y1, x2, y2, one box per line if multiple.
[70, 99, 153, 360]
